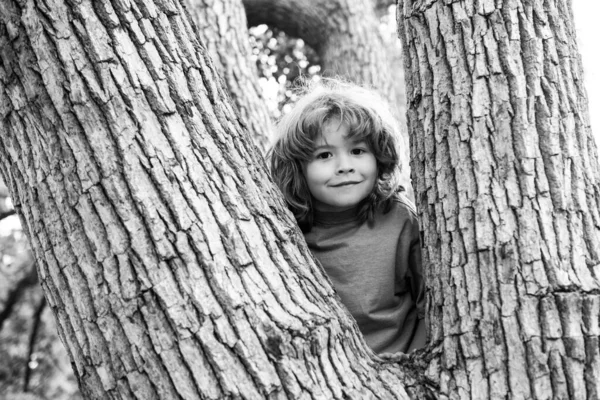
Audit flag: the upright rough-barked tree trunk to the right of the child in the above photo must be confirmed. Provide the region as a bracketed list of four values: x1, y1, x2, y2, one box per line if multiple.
[398, 0, 600, 399]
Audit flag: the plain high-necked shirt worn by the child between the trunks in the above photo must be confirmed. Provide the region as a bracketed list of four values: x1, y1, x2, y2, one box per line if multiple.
[305, 195, 426, 353]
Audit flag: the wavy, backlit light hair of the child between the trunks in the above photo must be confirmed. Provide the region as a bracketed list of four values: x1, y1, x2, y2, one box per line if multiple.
[267, 79, 401, 232]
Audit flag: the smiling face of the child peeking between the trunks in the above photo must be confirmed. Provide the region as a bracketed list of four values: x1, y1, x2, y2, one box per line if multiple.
[304, 120, 377, 211]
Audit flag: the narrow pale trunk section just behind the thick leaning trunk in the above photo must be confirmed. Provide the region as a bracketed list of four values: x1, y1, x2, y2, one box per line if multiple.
[186, 0, 274, 151]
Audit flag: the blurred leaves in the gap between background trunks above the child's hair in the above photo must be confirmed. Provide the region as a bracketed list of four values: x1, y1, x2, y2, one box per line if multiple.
[249, 25, 321, 117]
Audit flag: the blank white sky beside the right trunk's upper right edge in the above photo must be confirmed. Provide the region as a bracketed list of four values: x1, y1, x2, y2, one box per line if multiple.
[572, 0, 600, 142]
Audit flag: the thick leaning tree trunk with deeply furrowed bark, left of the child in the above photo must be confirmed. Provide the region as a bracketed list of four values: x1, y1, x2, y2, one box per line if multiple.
[0, 0, 426, 399]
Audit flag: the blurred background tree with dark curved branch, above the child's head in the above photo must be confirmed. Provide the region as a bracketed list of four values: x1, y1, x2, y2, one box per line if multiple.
[244, 0, 402, 108]
